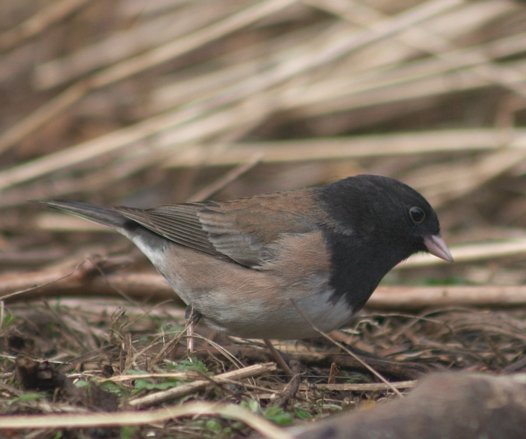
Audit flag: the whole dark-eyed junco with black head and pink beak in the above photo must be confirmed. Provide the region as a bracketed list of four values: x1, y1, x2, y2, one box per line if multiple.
[46, 175, 452, 339]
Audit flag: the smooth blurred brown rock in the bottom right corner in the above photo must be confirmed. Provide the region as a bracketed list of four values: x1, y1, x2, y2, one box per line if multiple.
[291, 372, 526, 439]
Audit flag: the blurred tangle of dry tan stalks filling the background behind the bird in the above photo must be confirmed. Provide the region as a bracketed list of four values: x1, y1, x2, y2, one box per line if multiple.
[0, 0, 526, 284]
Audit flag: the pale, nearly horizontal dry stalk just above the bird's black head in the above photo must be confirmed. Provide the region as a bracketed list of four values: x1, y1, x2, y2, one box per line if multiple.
[163, 128, 526, 169]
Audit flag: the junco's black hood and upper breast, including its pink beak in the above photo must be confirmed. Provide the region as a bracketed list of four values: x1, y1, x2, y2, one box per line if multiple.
[320, 175, 453, 310]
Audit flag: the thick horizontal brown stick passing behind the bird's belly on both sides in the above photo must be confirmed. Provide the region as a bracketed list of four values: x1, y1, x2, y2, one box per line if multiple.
[5, 269, 526, 310]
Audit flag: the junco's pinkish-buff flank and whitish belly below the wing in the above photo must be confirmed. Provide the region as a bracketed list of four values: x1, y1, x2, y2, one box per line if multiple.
[133, 229, 353, 339]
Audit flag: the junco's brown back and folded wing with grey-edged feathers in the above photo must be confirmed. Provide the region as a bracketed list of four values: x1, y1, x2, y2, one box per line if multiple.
[117, 189, 325, 267]
